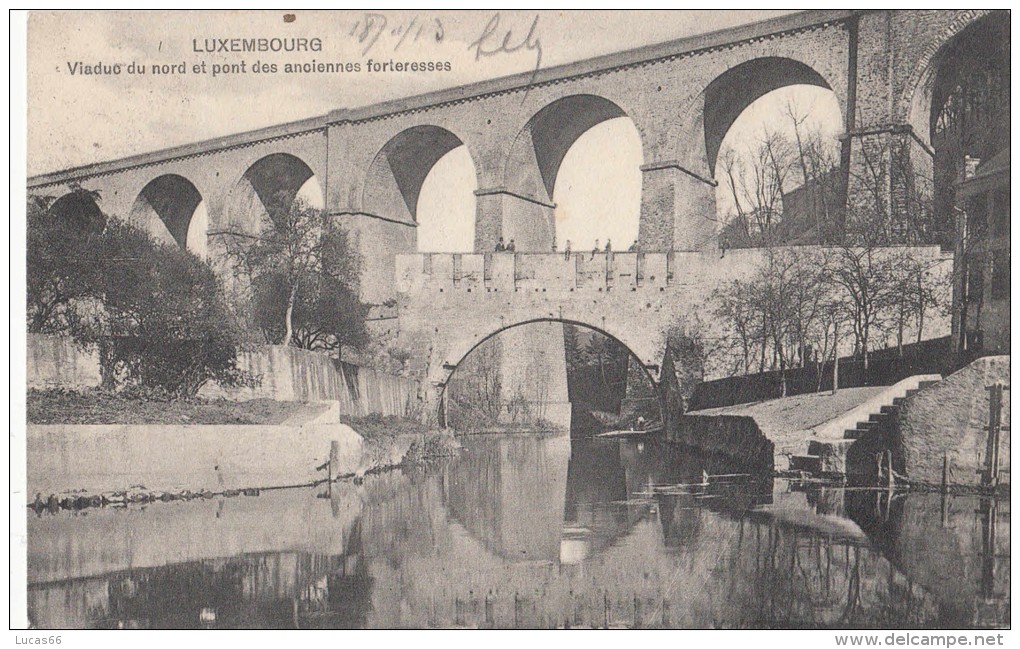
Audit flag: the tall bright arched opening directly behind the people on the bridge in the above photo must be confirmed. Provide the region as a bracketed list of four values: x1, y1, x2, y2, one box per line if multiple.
[506, 95, 644, 252]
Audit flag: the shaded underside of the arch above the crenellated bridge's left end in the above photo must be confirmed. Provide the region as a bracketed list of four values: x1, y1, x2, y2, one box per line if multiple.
[361, 126, 464, 222]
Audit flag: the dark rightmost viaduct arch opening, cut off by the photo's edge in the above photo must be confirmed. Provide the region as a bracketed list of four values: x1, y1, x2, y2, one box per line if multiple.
[928, 11, 1010, 244]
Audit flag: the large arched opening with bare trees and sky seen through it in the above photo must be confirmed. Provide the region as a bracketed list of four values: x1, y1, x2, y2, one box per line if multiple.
[705, 57, 846, 248]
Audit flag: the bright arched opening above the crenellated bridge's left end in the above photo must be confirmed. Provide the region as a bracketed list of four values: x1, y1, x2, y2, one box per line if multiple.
[362, 126, 478, 252]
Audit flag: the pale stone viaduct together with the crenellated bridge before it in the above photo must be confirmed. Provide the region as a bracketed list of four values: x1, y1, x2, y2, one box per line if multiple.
[29, 10, 995, 420]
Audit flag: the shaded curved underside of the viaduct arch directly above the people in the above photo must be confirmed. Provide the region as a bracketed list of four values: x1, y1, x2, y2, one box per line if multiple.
[505, 95, 627, 200]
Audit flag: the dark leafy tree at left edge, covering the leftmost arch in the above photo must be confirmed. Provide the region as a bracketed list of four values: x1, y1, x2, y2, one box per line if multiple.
[27, 186, 106, 334]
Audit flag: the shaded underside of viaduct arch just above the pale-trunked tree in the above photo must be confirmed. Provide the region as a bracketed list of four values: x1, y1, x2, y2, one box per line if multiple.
[227, 153, 315, 229]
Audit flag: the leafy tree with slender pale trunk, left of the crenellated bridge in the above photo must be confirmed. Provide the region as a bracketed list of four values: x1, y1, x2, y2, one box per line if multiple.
[212, 196, 368, 355]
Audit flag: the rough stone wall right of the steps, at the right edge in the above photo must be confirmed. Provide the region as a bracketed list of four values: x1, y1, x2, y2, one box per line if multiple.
[893, 356, 1010, 485]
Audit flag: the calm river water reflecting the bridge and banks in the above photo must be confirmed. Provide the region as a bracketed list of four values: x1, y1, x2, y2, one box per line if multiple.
[28, 436, 1010, 629]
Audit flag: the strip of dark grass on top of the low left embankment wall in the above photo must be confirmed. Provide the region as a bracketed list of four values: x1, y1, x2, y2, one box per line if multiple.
[28, 390, 324, 425]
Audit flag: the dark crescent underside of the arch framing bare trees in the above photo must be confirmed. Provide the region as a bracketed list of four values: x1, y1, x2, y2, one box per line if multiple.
[704, 56, 832, 176]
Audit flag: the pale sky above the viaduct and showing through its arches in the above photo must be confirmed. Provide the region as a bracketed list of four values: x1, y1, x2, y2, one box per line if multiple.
[28, 10, 839, 251]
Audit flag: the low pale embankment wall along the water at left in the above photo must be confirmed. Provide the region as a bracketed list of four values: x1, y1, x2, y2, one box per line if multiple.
[26, 423, 362, 495]
